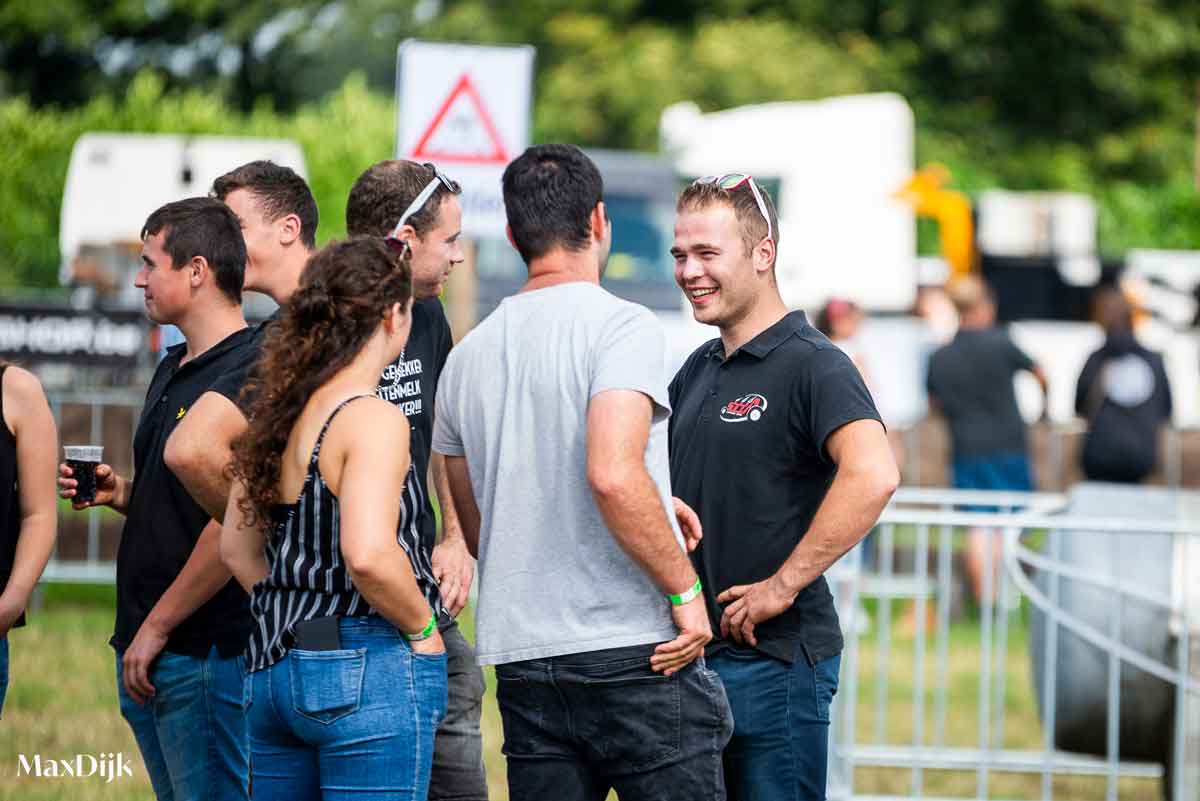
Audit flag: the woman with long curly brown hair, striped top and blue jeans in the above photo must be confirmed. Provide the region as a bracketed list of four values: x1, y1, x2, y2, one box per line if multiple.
[221, 237, 446, 801]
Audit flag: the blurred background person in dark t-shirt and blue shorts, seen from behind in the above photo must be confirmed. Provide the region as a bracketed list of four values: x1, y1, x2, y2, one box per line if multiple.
[925, 276, 1046, 601]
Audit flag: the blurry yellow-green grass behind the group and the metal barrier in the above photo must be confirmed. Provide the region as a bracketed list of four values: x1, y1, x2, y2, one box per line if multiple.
[0, 588, 1159, 801]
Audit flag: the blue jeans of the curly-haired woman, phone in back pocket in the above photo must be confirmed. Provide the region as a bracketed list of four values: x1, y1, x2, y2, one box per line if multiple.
[246, 616, 446, 801]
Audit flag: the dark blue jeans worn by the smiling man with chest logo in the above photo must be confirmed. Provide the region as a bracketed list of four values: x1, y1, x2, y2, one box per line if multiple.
[708, 646, 841, 801]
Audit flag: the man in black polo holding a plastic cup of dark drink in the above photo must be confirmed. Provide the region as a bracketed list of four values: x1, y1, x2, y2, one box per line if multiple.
[59, 198, 251, 801]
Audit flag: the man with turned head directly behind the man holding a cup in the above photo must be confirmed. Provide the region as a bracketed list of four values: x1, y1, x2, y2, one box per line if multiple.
[167, 161, 317, 520]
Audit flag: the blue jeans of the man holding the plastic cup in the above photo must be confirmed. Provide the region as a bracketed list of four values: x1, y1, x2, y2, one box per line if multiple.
[116, 648, 250, 801]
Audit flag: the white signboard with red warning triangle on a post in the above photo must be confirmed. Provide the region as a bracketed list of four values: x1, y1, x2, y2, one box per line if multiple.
[396, 40, 534, 237]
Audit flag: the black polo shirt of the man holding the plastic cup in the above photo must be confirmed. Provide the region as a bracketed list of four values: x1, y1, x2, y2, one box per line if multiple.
[110, 329, 253, 657]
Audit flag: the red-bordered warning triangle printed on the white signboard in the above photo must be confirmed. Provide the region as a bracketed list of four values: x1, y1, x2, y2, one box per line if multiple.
[412, 72, 509, 164]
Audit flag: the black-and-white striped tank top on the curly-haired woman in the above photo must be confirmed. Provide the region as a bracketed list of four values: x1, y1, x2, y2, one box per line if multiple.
[245, 395, 443, 670]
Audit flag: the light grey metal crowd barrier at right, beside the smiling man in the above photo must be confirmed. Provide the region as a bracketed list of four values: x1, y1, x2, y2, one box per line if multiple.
[829, 489, 1200, 801]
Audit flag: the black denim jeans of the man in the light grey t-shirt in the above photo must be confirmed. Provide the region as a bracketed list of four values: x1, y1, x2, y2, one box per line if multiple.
[496, 645, 733, 801]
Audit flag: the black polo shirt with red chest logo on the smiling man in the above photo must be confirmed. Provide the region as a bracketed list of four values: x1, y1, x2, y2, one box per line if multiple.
[670, 312, 880, 662]
